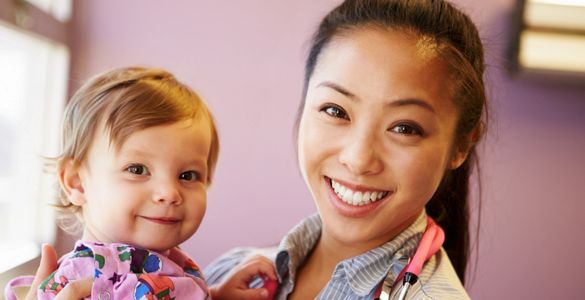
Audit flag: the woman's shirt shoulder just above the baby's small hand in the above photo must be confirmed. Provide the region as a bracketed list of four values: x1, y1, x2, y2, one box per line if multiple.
[203, 246, 278, 285]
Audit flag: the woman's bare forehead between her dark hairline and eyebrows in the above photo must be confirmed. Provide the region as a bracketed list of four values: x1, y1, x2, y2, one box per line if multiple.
[310, 29, 452, 106]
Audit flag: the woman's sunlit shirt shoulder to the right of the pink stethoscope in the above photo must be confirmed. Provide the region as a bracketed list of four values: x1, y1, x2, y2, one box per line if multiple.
[413, 249, 470, 299]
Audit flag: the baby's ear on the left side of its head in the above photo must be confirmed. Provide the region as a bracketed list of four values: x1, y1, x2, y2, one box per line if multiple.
[58, 158, 86, 206]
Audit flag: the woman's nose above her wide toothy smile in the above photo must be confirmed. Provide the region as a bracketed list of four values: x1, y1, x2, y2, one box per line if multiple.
[339, 130, 384, 175]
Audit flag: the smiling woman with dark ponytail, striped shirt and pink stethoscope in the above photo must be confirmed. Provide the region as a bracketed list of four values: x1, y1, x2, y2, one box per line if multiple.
[207, 0, 485, 299]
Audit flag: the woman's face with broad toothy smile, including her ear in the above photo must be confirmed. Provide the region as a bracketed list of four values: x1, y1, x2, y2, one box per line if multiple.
[299, 28, 466, 251]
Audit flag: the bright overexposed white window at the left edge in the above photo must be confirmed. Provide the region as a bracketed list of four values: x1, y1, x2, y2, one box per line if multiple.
[0, 0, 69, 273]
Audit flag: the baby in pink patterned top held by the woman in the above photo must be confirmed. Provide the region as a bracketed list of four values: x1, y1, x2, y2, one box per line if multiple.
[7, 67, 276, 299]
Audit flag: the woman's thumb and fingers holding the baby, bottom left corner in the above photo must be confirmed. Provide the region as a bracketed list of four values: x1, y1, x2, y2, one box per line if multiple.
[25, 244, 93, 300]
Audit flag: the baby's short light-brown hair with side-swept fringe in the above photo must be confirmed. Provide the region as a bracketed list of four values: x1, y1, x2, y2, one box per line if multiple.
[53, 67, 219, 233]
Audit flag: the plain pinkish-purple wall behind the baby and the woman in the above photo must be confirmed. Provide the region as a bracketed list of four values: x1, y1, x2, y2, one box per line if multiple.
[72, 0, 585, 299]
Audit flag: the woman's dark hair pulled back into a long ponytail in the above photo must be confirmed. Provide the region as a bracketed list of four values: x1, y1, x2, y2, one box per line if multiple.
[297, 0, 486, 283]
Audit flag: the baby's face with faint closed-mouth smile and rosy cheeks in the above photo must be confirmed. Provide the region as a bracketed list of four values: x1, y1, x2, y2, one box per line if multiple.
[79, 118, 211, 252]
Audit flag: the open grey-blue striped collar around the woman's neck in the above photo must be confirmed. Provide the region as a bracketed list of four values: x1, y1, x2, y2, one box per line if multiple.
[275, 211, 427, 296]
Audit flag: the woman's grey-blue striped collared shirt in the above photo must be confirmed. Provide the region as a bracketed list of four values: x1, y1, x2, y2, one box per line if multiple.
[204, 213, 469, 299]
